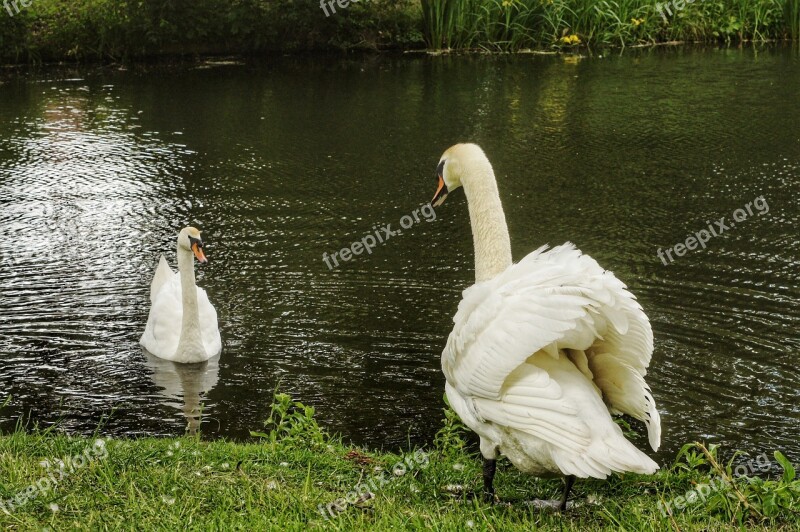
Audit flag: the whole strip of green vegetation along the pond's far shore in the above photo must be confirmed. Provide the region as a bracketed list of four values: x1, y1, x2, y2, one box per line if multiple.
[0, 0, 800, 63]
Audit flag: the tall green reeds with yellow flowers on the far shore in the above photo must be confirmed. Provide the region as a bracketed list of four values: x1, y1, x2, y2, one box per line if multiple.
[422, 0, 800, 51]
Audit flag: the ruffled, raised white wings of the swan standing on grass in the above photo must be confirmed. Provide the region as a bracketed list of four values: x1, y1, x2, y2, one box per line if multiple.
[442, 243, 660, 449]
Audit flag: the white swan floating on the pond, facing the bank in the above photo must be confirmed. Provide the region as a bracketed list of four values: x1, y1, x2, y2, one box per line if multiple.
[139, 227, 222, 364]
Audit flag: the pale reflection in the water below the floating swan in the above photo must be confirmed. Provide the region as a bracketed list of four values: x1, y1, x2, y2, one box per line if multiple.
[142, 349, 220, 436]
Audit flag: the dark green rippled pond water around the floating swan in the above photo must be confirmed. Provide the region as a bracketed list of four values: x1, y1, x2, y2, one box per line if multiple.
[0, 48, 800, 459]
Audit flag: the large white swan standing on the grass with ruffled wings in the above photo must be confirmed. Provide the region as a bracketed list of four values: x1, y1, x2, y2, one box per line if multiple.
[431, 144, 661, 510]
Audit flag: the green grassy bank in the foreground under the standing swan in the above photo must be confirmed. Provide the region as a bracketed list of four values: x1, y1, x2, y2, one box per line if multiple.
[0, 396, 800, 531]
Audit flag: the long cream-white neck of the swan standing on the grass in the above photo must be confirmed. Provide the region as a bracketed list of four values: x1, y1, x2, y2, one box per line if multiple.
[461, 156, 511, 282]
